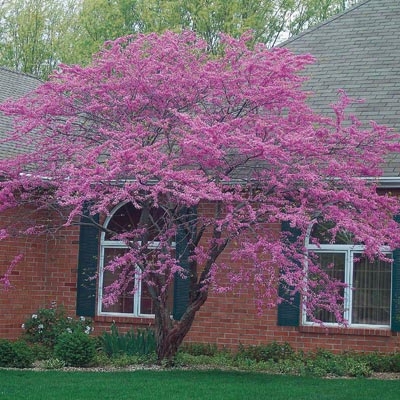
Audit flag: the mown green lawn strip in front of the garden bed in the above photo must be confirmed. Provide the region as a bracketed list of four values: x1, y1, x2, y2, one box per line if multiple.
[0, 369, 400, 400]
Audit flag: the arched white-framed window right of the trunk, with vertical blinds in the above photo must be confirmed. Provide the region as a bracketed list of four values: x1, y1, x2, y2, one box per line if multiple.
[303, 224, 392, 328]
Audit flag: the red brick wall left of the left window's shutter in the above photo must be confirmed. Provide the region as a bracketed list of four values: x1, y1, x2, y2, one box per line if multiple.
[0, 210, 79, 338]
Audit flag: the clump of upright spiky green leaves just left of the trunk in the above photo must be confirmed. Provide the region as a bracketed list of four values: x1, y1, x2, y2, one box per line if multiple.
[99, 324, 157, 357]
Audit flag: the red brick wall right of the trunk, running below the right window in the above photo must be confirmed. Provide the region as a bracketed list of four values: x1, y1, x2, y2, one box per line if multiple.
[186, 294, 400, 353]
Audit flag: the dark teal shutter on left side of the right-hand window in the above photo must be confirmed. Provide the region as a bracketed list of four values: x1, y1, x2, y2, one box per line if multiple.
[277, 221, 300, 326]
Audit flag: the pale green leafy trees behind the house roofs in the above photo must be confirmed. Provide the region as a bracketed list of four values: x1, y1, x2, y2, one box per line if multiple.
[0, 0, 355, 78]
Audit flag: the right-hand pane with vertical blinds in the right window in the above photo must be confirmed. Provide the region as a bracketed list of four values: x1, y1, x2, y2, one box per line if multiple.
[352, 254, 392, 325]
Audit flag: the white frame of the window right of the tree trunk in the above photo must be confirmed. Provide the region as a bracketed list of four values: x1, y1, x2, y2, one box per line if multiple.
[302, 242, 393, 329]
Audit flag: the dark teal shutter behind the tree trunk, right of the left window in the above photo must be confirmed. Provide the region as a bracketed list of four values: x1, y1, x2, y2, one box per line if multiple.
[172, 207, 197, 321]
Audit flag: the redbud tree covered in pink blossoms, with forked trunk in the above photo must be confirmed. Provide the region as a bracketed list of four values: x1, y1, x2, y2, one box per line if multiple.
[0, 32, 400, 360]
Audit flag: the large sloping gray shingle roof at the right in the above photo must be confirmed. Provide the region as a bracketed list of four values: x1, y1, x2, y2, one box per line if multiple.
[282, 0, 400, 177]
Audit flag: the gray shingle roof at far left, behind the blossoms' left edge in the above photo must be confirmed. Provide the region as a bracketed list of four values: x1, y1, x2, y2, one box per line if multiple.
[0, 67, 41, 158]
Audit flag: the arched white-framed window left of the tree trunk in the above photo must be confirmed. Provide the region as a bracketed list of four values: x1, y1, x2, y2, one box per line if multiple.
[98, 203, 172, 317]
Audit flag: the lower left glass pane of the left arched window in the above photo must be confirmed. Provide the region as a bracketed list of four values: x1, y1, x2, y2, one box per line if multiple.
[101, 248, 135, 314]
